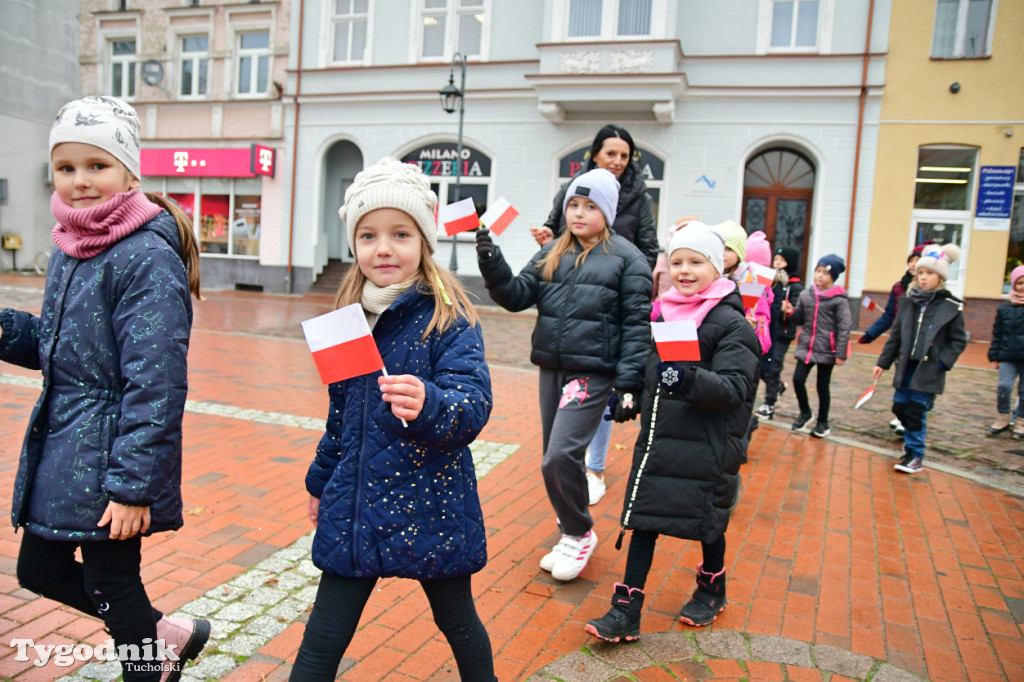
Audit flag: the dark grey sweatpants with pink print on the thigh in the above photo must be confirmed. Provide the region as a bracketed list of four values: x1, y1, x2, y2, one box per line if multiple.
[539, 368, 610, 536]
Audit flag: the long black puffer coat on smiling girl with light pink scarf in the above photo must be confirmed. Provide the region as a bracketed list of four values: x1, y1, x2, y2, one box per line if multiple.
[622, 291, 761, 543]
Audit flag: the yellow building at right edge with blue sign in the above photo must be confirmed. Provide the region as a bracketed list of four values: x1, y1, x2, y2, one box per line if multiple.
[861, 0, 1024, 339]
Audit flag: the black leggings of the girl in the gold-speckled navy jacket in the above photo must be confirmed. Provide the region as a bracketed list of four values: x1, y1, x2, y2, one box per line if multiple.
[289, 573, 496, 682]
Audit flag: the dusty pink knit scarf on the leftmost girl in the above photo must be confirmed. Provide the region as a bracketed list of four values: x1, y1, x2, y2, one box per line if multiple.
[50, 189, 163, 258]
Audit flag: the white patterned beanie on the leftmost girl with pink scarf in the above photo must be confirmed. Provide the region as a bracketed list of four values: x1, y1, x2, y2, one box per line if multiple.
[50, 96, 142, 180]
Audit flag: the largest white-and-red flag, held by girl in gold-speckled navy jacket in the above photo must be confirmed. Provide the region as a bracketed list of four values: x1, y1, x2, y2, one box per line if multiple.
[302, 303, 384, 384]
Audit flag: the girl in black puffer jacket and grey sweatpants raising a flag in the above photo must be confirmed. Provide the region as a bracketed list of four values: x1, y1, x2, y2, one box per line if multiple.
[476, 168, 653, 581]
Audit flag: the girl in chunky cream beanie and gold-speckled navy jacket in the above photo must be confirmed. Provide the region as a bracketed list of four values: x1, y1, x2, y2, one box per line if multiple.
[291, 159, 495, 682]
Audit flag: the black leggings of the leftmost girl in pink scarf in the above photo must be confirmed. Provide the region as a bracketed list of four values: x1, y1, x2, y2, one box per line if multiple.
[17, 530, 163, 682]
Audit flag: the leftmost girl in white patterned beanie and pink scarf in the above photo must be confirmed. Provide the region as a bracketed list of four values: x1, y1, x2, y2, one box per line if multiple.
[0, 97, 210, 682]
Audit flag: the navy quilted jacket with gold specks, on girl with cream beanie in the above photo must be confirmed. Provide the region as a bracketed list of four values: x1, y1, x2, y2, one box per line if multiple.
[306, 287, 492, 580]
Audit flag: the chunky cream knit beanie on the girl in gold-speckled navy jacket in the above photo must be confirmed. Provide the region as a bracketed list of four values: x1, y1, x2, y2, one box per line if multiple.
[338, 157, 437, 253]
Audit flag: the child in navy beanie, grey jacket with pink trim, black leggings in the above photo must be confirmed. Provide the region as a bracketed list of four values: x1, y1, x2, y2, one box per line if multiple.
[782, 254, 852, 438]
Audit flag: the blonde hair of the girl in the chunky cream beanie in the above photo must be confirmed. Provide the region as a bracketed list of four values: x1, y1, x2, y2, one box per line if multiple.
[334, 235, 480, 341]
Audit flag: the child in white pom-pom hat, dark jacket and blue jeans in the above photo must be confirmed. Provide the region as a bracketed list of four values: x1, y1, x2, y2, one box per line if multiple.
[872, 244, 967, 474]
